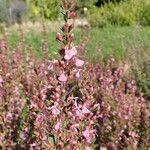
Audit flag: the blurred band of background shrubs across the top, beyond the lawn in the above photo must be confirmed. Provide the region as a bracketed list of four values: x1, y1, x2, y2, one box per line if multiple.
[0, 0, 150, 27]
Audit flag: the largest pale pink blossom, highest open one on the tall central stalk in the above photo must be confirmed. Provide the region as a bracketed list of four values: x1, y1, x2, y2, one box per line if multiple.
[64, 47, 77, 60]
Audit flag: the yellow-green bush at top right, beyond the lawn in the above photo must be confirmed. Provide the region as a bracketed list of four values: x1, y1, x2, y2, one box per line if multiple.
[88, 0, 150, 27]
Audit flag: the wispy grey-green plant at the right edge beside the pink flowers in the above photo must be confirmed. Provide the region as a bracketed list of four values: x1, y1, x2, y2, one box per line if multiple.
[126, 27, 150, 99]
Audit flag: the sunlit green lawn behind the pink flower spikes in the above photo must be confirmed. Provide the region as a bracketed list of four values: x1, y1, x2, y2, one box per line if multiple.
[2, 27, 150, 60]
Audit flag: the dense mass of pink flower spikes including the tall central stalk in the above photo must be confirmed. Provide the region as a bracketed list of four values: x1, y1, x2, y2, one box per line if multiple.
[0, 0, 150, 150]
